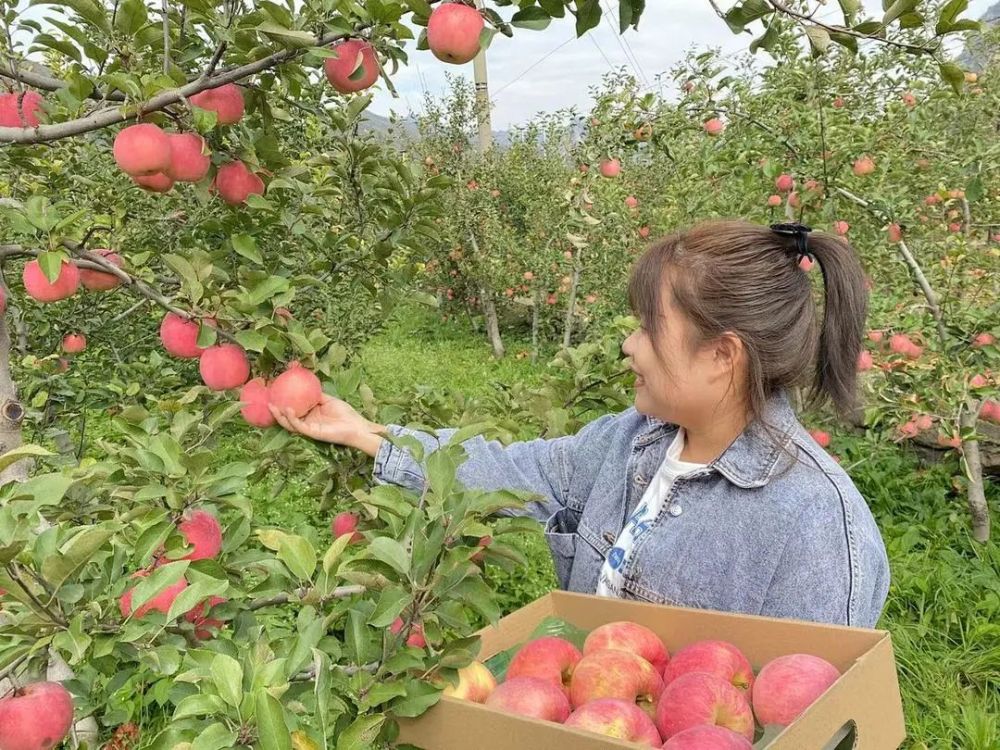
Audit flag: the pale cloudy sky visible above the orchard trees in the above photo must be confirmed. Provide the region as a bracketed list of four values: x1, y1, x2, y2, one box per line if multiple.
[371, 0, 994, 130]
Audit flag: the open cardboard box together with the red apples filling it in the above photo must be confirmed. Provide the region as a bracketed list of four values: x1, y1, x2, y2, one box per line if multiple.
[398, 591, 905, 750]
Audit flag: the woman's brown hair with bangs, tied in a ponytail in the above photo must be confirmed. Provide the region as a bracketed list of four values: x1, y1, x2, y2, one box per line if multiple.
[628, 221, 868, 420]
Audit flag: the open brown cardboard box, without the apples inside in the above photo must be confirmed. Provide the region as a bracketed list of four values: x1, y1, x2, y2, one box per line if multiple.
[398, 591, 906, 750]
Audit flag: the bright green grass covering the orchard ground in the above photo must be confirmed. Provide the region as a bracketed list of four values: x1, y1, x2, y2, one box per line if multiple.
[74, 306, 1000, 750]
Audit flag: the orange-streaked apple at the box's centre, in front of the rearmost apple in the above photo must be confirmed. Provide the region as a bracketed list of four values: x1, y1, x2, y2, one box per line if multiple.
[569, 649, 663, 716]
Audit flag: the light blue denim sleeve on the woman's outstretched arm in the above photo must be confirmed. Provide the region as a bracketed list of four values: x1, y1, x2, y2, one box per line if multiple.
[372, 414, 617, 523]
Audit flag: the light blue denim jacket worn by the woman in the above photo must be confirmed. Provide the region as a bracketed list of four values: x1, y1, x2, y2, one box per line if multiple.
[373, 393, 889, 627]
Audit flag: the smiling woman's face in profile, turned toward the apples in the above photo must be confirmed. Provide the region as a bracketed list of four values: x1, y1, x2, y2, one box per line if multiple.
[622, 284, 733, 428]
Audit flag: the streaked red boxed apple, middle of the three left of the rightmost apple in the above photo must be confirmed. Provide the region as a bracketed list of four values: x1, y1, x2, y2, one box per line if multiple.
[656, 672, 756, 741]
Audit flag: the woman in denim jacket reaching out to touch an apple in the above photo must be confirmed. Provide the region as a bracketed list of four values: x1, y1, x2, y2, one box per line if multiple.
[275, 221, 889, 627]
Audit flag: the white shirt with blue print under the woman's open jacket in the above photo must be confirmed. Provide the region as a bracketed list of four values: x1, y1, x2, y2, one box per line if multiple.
[596, 428, 705, 597]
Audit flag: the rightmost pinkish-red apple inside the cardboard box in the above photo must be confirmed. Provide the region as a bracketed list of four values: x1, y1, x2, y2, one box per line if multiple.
[751, 654, 840, 737]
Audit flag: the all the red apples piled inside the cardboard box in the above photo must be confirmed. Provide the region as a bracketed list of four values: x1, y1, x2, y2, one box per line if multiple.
[444, 621, 840, 750]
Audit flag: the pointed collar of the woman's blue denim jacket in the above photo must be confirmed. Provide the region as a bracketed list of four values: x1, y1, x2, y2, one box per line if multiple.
[636, 391, 797, 489]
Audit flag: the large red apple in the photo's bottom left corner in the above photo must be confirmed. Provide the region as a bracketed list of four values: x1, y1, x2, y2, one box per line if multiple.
[0, 682, 73, 750]
